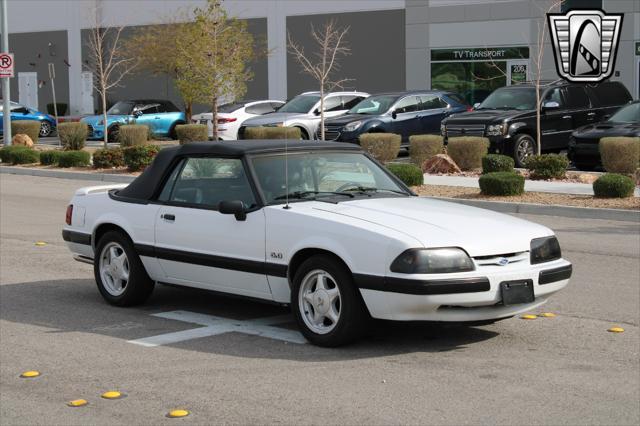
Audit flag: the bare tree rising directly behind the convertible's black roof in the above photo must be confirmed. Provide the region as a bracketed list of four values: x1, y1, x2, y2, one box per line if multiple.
[287, 21, 351, 140]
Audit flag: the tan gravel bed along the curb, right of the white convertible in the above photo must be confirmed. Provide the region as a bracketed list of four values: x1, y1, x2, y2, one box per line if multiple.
[411, 185, 640, 210]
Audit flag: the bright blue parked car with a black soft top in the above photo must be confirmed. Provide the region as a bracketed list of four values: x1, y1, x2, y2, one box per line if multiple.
[80, 99, 186, 142]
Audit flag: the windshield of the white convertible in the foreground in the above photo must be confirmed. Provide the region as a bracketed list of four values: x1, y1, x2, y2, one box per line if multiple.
[251, 152, 409, 204]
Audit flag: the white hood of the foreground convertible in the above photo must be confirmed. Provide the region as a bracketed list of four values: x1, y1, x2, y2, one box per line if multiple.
[314, 197, 553, 256]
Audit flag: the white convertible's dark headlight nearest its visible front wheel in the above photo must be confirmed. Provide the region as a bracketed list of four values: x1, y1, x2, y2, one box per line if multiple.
[391, 247, 475, 274]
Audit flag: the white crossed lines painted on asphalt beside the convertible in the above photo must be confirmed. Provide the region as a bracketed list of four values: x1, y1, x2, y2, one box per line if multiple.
[129, 311, 307, 347]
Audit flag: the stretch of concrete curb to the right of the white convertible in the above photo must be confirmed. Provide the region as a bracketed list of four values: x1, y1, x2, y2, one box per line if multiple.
[427, 197, 640, 223]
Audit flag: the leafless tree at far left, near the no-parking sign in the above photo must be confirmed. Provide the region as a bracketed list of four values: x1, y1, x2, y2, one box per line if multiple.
[85, 1, 137, 148]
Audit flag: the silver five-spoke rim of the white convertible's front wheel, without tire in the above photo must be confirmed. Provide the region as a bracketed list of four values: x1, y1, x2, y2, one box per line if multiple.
[298, 269, 341, 334]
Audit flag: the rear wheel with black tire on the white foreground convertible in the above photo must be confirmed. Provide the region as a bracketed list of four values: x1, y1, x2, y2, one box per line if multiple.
[93, 231, 154, 306]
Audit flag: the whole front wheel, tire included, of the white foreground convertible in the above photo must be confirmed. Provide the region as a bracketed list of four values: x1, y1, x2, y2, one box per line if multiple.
[291, 255, 368, 347]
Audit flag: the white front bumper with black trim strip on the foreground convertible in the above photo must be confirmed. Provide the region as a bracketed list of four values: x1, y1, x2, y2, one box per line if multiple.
[355, 259, 572, 322]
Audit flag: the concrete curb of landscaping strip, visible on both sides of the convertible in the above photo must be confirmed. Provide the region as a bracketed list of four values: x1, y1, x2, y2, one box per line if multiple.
[0, 166, 640, 223]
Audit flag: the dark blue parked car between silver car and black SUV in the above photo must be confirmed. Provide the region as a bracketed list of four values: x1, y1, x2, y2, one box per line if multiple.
[316, 90, 471, 147]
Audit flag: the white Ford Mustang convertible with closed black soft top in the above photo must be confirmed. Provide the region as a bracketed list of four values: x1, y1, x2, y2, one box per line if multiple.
[62, 141, 571, 346]
